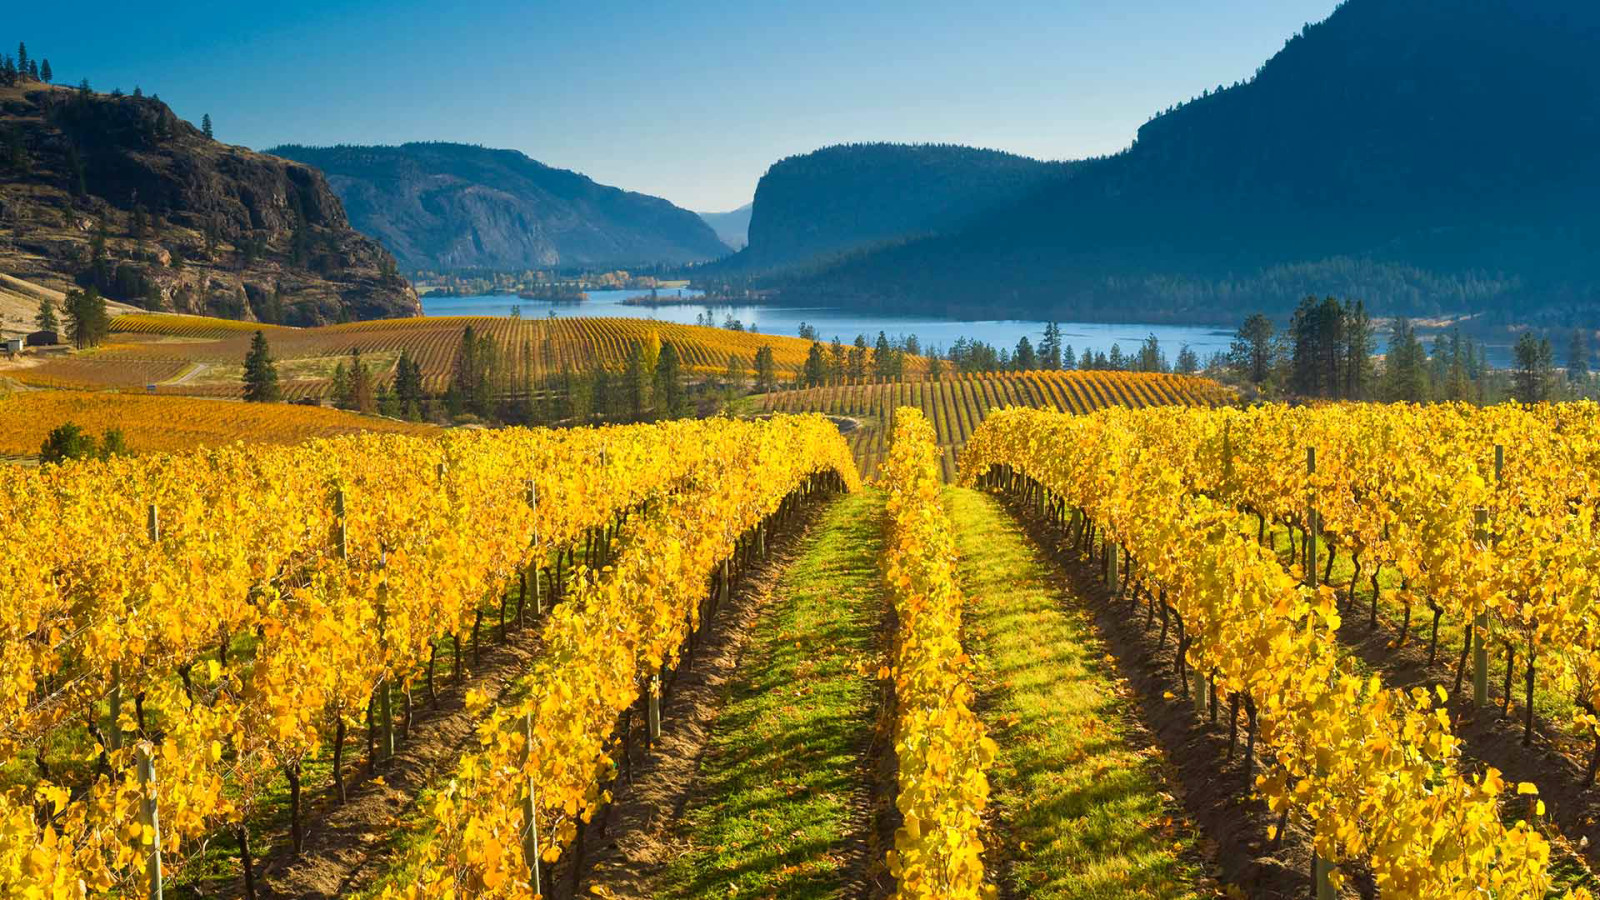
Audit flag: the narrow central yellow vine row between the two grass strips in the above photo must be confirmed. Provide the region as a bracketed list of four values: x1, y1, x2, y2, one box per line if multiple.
[882, 407, 997, 900]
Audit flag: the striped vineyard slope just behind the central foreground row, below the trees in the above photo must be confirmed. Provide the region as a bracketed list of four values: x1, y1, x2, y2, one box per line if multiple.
[763, 372, 1234, 482]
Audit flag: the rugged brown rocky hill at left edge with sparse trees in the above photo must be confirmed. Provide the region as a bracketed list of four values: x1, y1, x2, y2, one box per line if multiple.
[0, 80, 421, 325]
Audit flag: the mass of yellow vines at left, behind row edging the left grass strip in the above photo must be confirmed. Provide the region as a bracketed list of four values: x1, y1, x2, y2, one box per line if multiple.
[0, 421, 864, 895]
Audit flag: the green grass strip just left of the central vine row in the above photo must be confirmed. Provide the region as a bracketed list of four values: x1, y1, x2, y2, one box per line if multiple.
[653, 492, 886, 900]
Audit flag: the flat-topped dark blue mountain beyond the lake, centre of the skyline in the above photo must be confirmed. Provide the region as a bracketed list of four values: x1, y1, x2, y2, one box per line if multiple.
[709, 144, 1067, 272]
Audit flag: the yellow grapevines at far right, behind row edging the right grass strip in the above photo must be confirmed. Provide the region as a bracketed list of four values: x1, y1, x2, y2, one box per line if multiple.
[1113, 404, 1600, 759]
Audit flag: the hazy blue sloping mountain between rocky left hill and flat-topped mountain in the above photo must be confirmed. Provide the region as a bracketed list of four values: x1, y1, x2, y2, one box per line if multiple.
[269, 143, 728, 271]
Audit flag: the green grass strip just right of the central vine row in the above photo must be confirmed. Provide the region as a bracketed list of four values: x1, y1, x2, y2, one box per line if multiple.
[946, 490, 1214, 900]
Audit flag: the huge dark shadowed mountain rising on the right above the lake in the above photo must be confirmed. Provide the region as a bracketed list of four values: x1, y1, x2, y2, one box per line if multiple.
[784, 0, 1600, 322]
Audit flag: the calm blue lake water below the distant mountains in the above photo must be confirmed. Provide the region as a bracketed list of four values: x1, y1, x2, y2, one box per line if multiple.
[422, 288, 1234, 362]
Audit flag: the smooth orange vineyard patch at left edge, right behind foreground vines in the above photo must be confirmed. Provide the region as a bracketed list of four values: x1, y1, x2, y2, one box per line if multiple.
[0, 391, 438, 456]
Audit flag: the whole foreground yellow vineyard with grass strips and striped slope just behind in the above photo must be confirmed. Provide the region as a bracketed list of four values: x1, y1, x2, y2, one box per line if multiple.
[9, 398, 1600, 900]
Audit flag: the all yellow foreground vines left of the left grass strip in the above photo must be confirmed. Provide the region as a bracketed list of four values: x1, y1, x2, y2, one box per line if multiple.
[0, 418, 854, 897]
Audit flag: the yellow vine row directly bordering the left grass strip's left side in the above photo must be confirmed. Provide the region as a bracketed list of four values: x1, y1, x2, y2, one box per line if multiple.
[386, 416, 859, 900]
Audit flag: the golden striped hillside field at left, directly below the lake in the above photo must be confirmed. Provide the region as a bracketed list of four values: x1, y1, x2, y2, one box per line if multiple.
[6, 314, 889, 400]
